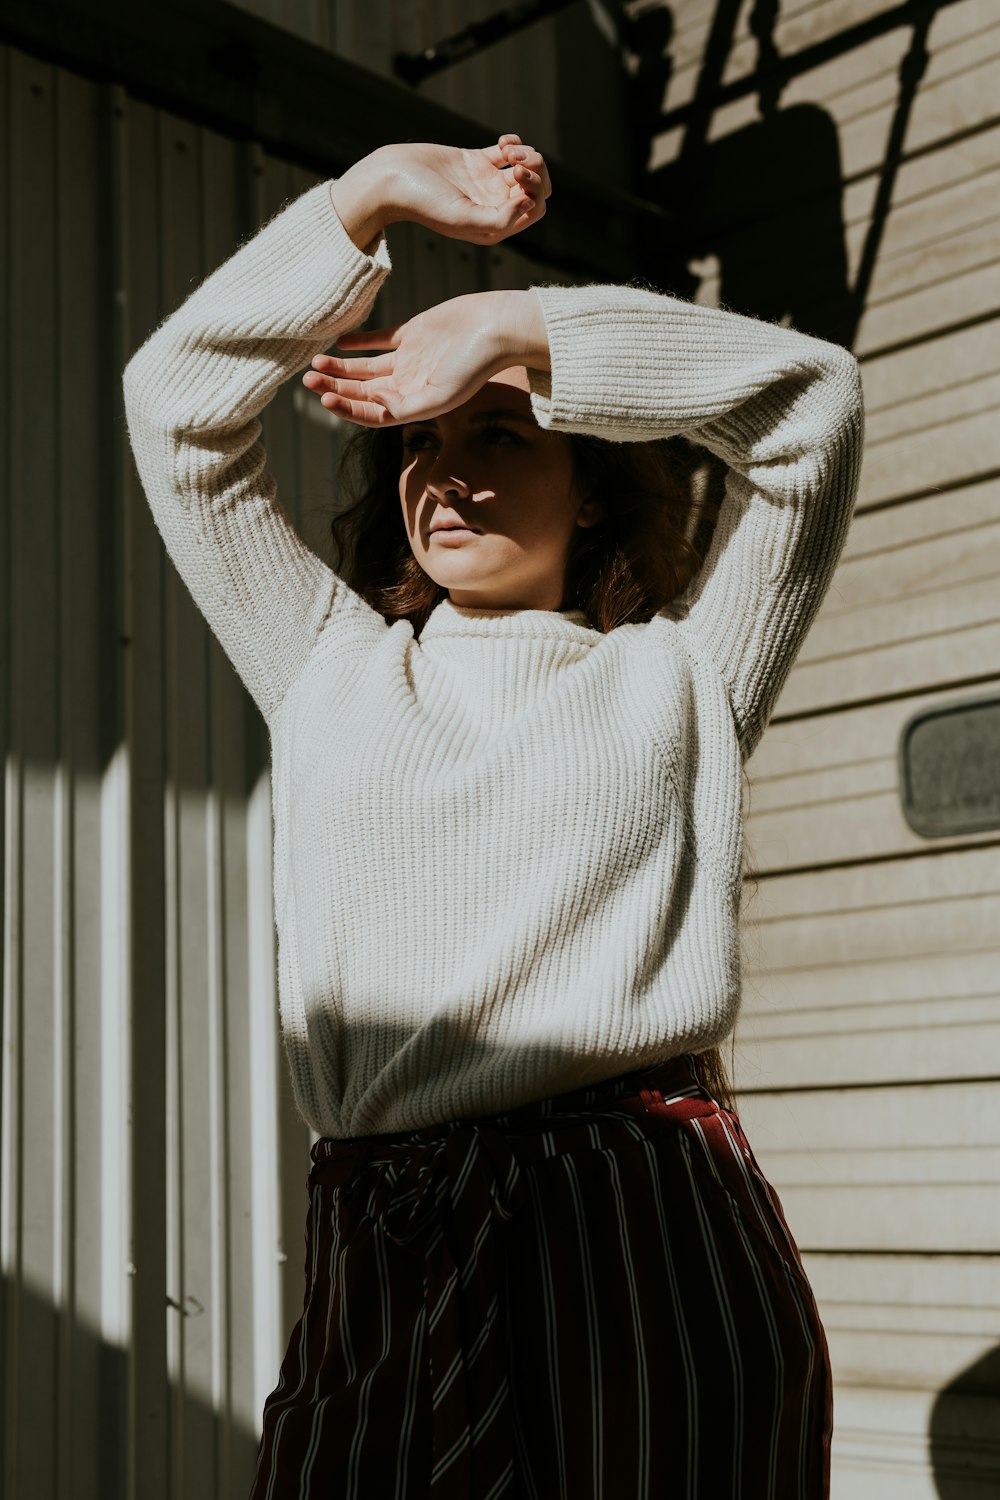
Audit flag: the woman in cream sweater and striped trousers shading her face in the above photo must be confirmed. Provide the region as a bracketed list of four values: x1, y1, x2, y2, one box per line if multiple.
[126, 135, 861, 1500]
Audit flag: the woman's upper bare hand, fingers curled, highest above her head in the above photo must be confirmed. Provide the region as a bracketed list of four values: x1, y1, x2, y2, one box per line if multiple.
[340, 135, 552, 245]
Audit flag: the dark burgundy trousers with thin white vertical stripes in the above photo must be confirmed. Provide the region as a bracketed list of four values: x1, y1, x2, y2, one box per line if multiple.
[250, 1058, 832, 1500]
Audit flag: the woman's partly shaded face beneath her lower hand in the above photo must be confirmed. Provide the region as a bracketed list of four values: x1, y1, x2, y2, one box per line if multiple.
[399, 366, 601, 609]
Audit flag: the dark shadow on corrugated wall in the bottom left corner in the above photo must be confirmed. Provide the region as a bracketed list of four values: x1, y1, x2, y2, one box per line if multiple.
[0, 1278, 258, 1500]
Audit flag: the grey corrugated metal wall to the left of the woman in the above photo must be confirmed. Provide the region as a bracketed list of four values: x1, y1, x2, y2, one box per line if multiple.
[0, 8, 578, 1500]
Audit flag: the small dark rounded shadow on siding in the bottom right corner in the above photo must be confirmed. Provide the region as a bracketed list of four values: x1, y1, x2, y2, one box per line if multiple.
[931, 1346, 1000, 1500]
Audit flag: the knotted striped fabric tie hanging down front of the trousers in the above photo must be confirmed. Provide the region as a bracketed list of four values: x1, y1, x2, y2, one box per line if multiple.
[341, 1121, 523, 1500]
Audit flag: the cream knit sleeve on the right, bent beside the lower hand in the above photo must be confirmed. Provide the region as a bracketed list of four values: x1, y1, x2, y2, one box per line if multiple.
[531, 287, 864, 759]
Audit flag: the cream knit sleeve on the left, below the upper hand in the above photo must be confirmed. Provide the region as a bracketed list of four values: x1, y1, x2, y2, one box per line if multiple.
[124, 182, 391, 723]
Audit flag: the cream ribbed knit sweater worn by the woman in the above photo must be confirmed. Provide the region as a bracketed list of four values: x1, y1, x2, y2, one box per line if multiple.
[124, 183, 862, 1137]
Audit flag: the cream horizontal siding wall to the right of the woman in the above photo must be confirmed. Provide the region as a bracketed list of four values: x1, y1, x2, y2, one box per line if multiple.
[634, 0, 1000, 1500]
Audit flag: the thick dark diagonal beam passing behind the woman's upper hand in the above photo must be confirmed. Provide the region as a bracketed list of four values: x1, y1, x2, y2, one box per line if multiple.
[0, 0, 672, 281]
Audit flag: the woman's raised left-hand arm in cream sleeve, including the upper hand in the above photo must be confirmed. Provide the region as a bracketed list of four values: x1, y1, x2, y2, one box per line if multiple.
[124, 137, 550, 722]
